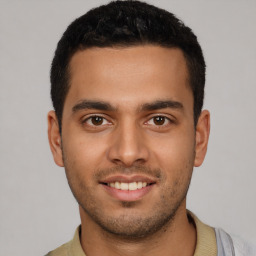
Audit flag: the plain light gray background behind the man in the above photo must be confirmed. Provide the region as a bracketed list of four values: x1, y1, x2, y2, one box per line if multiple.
[0, 0, 256, 256]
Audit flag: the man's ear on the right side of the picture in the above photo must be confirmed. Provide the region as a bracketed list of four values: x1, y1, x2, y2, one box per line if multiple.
[194, 110, 210, 167]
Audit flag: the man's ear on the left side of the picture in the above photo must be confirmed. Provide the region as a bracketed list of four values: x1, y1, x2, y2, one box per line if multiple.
[47, 110, 64, 167]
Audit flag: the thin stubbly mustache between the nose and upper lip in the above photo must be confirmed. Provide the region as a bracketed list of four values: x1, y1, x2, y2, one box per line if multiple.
[94, 165, 164, 180]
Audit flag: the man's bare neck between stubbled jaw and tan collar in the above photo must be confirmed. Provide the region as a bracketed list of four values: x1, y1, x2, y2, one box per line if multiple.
[80, 202, 196, 256]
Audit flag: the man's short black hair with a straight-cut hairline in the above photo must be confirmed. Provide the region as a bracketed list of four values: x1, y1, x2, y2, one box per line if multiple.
[51, 0, 205, 131]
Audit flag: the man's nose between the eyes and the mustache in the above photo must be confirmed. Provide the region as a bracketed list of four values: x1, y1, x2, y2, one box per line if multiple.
[107, 123, 149, 167]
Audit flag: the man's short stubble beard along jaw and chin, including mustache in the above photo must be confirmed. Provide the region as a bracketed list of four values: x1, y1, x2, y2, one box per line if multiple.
[64, 158, 193, 240]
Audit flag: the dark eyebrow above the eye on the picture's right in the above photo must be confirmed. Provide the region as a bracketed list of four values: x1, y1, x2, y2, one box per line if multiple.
[141, 100, 184, 111]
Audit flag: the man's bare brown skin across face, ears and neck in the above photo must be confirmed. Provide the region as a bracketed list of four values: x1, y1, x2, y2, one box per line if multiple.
[48, 45, 210, 256]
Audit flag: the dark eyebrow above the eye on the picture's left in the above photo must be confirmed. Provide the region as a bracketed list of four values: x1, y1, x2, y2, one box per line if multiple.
[72, 100, 115, 113]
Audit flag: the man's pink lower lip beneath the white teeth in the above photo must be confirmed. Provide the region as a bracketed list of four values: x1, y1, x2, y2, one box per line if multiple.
[101, 184, 154, 202]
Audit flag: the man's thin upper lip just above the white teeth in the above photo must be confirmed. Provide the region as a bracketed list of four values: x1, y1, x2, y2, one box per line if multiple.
[100, 175, 156, 184]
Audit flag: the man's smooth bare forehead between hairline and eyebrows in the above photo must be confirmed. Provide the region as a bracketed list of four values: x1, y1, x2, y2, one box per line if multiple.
[64, 45, 193, 113]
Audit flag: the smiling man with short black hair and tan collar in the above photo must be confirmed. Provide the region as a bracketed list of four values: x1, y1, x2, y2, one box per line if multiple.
[45, 1, 252, 256]
